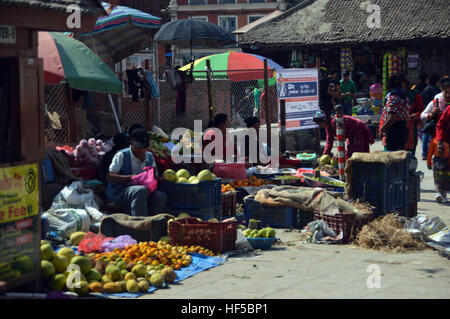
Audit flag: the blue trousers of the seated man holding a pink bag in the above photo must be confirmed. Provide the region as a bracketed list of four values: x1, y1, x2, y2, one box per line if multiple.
[116, 186, 167, 216]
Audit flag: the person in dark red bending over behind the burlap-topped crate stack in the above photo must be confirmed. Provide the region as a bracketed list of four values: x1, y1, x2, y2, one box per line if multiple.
[313, 110, 375, 159]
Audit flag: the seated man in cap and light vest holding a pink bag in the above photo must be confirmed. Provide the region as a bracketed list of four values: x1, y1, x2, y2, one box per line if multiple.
[106, 129, 167, 216]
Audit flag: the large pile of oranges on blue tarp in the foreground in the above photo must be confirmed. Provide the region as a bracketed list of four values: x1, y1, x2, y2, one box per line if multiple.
[94, 241, 214, 270]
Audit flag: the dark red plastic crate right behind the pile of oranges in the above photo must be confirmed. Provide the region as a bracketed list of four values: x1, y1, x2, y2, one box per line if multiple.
[169, 218, 237, 254]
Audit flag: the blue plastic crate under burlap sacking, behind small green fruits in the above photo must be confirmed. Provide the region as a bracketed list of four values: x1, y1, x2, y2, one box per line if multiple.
[244, 197, 295, 228]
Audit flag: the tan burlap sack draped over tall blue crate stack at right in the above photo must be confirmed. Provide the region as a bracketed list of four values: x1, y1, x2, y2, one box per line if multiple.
[345, 151, 409, 198]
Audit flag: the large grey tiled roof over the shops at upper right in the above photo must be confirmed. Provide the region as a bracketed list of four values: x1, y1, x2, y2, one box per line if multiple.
[239, 0, 450, 47]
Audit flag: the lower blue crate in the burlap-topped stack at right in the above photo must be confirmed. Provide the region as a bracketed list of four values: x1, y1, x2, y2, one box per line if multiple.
[353, 181, 409, 216]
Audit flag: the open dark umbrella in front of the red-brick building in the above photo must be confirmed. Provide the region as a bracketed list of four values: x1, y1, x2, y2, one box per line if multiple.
[154, 19, 236, 56]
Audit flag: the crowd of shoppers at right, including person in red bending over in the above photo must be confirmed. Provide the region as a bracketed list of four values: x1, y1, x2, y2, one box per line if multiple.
[314, 69, 450, 203]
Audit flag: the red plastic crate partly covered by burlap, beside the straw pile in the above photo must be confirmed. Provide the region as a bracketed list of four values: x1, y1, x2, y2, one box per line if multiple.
[314, 211, 373, 244]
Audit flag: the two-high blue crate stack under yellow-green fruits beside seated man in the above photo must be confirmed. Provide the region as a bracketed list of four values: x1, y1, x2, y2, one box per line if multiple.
[162, 178, 222, 220]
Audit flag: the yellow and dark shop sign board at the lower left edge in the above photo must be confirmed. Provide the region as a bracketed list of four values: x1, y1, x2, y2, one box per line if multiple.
[0, 164, 40, 282]
